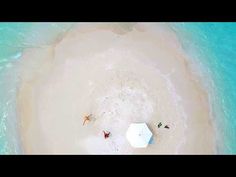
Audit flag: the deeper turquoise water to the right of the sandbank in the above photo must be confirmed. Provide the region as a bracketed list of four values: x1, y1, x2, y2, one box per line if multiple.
[173, 23, 236, 154]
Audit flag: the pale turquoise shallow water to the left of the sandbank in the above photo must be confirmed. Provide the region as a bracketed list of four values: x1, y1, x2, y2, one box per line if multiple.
[0, 23, 73, 154]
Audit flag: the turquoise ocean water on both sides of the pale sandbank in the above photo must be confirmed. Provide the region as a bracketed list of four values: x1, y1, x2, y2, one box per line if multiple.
[0, 23, 236, 154]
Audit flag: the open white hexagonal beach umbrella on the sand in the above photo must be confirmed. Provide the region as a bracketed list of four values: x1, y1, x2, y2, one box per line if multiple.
[126, 123, 152, 148]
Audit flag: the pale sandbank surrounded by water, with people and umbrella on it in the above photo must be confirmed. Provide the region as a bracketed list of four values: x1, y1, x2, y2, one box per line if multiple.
[18, 23, 215, 154]
